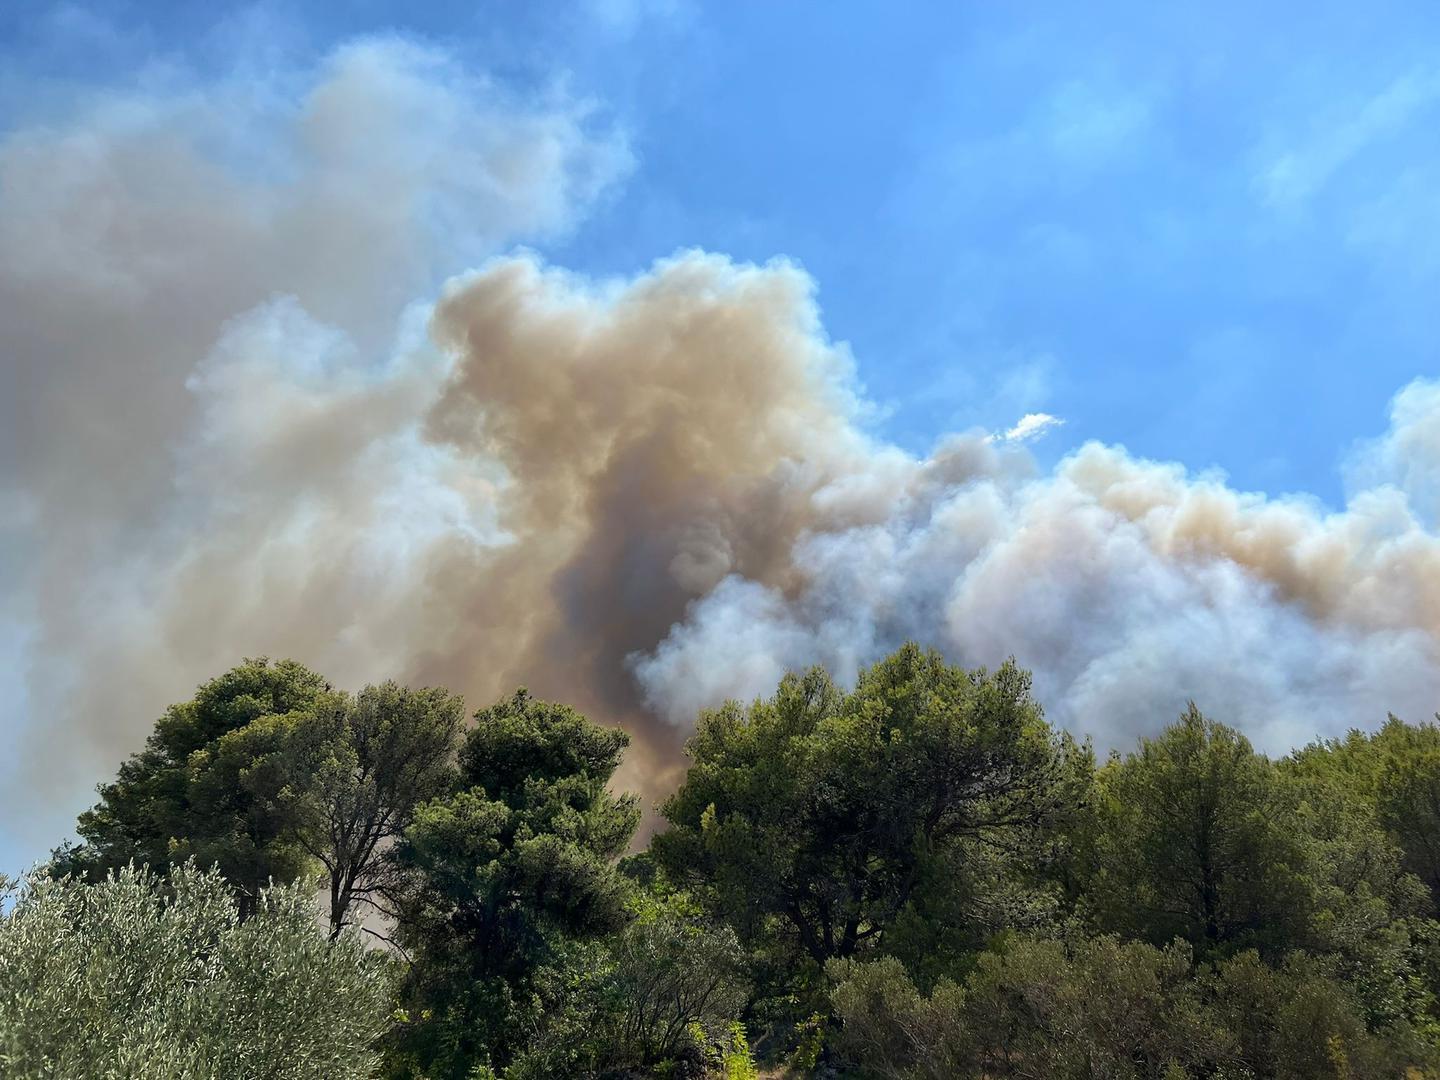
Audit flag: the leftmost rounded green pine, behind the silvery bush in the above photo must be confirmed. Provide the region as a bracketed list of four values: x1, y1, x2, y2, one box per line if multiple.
[55, 658, 330, 914]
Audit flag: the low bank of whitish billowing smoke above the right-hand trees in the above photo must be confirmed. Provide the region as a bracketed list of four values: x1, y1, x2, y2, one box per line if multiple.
[635, 423, 1440, 750]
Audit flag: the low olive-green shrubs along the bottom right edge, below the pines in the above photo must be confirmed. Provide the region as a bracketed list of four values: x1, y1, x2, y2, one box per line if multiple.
[831, 936, 1434, 1080]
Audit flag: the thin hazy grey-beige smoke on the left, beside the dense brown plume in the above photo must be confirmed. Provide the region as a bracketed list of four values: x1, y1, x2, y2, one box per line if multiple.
[0, 39, 631, 850]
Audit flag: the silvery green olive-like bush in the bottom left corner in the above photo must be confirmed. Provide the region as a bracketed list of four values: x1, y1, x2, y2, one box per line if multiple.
[0, 865, 390, 1080]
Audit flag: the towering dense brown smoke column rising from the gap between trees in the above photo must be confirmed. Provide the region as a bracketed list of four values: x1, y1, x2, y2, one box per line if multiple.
[411, 253, 868, 791]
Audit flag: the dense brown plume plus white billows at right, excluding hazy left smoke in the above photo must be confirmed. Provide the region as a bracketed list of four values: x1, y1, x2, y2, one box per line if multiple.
[408, 253, 1440, 766]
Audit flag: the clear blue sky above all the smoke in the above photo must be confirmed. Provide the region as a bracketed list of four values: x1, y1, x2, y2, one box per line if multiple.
[0, 0, 1440, 504]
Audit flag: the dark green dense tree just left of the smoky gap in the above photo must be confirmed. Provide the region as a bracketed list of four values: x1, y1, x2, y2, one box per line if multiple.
[392, 690, 639, 1077]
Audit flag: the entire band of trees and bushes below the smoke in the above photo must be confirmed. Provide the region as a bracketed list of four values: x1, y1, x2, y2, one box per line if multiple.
[11, 644, 1440, 1080]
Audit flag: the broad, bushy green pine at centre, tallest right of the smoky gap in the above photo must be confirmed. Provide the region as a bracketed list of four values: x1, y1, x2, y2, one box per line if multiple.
[652, 645, 1084, 971]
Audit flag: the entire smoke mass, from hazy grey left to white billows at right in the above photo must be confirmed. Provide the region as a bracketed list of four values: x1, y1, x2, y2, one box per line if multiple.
[0, 33, 1440, 869]
